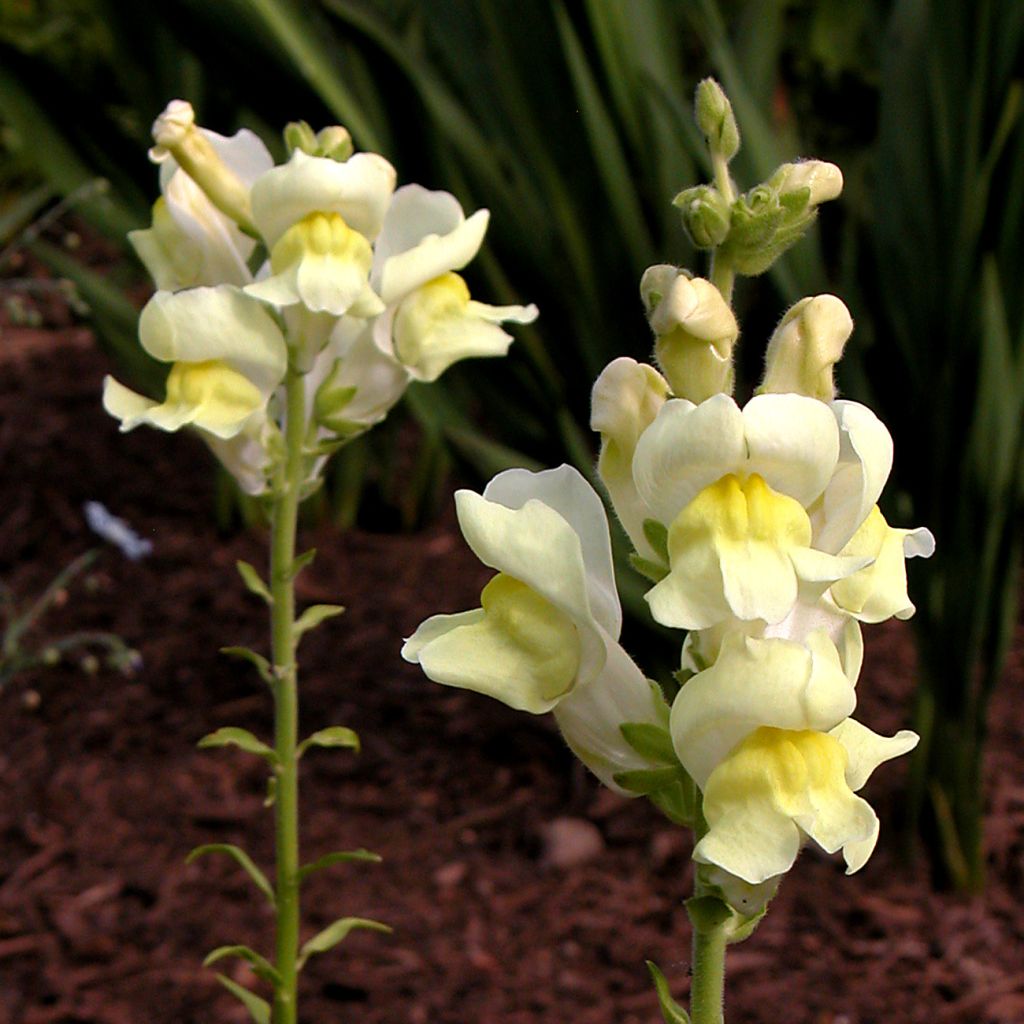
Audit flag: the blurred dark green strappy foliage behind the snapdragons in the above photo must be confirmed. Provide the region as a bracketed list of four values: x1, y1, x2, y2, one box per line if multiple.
[0, 0, 1024, 888]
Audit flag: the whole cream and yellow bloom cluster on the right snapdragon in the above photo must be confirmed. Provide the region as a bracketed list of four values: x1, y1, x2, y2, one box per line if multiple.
[403, 258, 934, 912]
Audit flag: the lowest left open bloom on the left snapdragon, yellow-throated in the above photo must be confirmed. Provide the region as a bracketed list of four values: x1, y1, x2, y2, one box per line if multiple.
[103, 285, 287, 440]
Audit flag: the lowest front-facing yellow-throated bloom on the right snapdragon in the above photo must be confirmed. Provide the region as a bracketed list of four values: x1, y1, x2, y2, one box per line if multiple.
[671, 631, 918, 886]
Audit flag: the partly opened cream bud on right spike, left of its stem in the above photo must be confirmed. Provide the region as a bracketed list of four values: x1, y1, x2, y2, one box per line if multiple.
[640, 265, 739, 403]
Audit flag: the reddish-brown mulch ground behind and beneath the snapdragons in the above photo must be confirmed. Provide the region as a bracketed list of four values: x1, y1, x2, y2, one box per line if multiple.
[0, 329, 1024, 1024]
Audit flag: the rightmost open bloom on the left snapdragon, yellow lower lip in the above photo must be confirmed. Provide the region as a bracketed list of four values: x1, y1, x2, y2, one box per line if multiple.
[371, 185, 537, 381]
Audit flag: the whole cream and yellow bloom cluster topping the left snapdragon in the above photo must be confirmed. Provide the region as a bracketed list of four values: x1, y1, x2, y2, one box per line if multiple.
[103, 100, 537, 494]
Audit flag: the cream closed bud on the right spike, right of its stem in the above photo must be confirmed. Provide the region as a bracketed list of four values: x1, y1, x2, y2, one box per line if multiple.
[758, 295, 853, 401]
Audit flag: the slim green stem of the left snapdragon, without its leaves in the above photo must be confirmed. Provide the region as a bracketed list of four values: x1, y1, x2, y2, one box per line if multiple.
[270, 368, 306, 1024]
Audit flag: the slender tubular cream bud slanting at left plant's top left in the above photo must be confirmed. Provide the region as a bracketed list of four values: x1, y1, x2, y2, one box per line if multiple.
[150, 99, 256, 233]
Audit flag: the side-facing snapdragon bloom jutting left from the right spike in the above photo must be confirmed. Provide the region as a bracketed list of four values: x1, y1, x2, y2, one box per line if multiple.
[402, 466, 662, 792]
